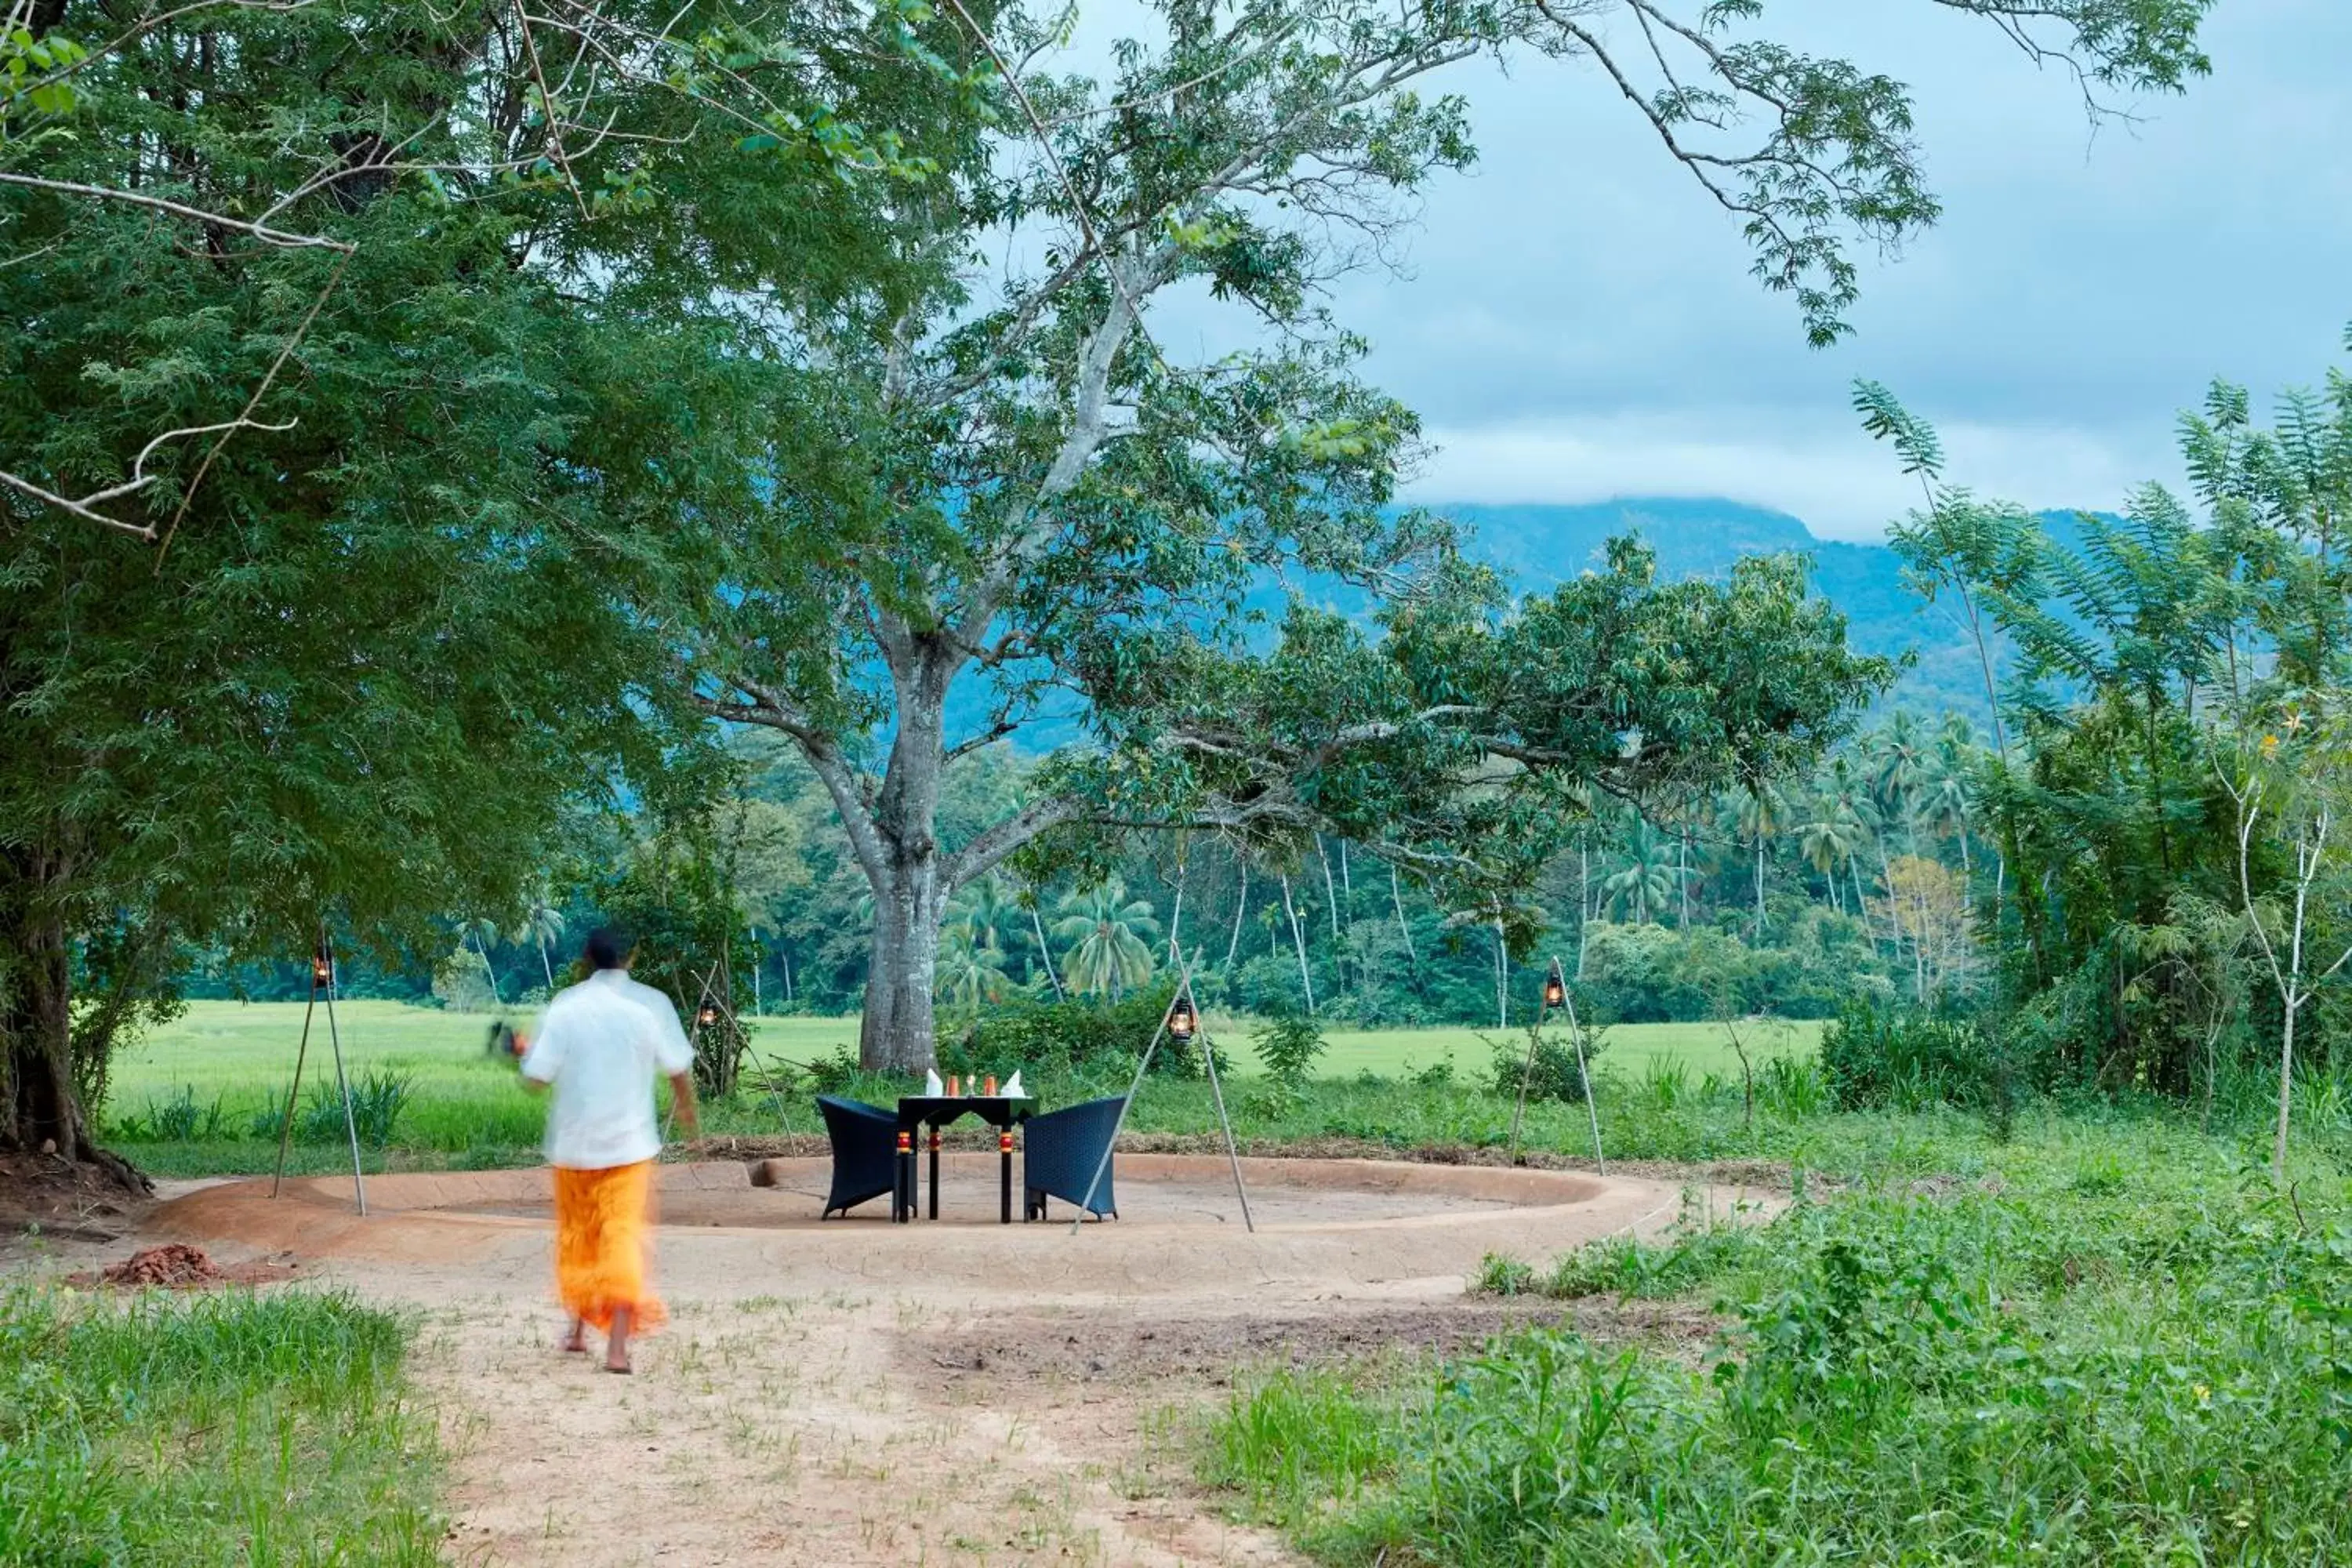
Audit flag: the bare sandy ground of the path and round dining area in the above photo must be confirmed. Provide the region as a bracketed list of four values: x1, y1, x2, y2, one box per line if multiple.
[106, 1156, 1778, 1568]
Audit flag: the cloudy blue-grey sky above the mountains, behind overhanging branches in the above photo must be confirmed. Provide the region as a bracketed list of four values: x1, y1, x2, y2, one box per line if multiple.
[1129, 0, 2352, 539]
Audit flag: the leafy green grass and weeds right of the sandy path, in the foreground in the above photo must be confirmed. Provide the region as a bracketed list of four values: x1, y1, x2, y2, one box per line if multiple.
[1202, 1105, 2352, 1568]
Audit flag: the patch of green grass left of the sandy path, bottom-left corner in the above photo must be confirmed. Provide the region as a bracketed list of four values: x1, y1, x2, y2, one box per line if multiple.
[0, 1283, 442, 1568]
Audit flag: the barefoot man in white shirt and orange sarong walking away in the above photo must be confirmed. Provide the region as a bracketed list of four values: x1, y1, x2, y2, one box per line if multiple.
[522, 926, 696, 1373]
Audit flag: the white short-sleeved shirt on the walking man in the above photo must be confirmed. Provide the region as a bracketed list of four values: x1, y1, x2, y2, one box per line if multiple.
[522, 968, 694, 1171]
